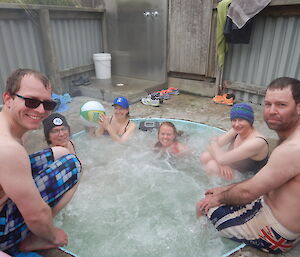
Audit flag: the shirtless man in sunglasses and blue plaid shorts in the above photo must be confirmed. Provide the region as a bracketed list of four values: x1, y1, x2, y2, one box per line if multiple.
[0, 69, 81, 253]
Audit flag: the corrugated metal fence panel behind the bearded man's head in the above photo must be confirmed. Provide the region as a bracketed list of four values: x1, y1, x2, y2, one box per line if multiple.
[223, 13, 300, 104]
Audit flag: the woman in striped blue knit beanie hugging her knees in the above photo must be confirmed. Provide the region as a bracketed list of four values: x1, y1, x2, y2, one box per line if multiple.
[200, 103, 269, 179]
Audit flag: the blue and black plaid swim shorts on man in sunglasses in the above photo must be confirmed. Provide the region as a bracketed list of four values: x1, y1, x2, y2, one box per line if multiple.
[0, 148, 81, 250]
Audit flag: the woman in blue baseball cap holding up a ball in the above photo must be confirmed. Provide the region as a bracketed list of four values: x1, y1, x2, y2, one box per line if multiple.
[95, 96, 136, 142]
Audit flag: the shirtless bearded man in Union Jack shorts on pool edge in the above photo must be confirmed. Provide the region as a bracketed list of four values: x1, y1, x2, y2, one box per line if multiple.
[197, 77, 300, 253]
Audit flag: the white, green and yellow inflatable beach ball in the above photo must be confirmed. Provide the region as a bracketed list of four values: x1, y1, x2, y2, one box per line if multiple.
[80, 101, 105, 127]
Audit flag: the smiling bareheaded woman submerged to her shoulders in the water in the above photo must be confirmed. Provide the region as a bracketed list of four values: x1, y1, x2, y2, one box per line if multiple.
[154, 121, 189, 155]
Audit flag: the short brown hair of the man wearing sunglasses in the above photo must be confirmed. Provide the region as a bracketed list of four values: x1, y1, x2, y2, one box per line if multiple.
[5, 69, 51, 96]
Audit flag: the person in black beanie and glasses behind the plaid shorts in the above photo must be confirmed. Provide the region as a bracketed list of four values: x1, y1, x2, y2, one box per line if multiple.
[43, 113, 76, 154]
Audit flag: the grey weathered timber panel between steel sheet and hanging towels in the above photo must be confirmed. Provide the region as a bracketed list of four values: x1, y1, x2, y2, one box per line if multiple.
[169, 0, 216, 78]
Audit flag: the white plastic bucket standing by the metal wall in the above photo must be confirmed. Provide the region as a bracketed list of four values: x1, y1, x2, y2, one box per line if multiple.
[93, 53, 111, 79]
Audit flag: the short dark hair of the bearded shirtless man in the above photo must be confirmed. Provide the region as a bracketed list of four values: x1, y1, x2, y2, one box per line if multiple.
[267, 77, 300, 104]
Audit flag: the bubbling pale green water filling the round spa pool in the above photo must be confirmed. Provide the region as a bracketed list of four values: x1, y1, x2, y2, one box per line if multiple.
[55, 119, 248, 257]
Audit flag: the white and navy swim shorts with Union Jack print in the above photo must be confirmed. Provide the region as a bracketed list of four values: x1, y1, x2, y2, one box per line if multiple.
[207, 197, 300, 254]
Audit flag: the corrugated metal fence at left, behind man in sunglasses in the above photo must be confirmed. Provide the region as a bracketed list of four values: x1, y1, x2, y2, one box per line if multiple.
[0, 5, 103, 103]
